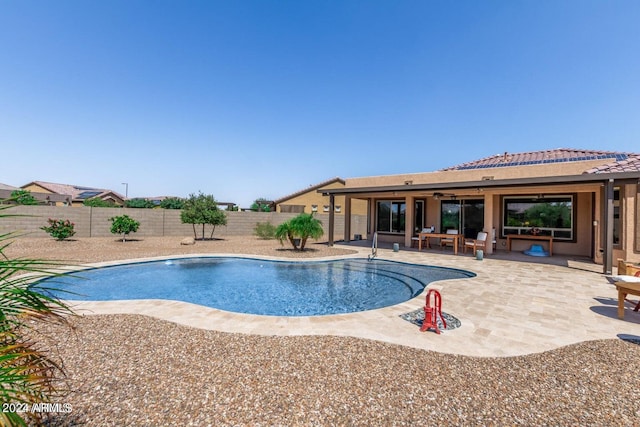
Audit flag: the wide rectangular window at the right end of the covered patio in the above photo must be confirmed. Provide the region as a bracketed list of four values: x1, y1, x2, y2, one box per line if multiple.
[502, 195, 575, 240]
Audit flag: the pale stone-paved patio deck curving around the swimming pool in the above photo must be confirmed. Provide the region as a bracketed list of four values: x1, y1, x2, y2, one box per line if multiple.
[74, 241, 640, 357]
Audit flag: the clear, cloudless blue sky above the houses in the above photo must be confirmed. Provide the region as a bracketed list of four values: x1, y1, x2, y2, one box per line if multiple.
[0, 0, 640, 207]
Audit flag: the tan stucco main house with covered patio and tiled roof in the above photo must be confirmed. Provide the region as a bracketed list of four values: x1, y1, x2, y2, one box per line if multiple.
[323, 148, 640, 273]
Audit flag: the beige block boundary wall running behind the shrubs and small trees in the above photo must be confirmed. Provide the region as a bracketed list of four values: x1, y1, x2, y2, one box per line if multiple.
[0, 206, 367, 239]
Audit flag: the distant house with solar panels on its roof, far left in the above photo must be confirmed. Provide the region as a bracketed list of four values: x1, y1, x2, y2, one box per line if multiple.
[20, 181, 125, 206]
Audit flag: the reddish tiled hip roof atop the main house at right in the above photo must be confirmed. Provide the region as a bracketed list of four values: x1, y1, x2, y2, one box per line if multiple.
[441, 148, 634, 171]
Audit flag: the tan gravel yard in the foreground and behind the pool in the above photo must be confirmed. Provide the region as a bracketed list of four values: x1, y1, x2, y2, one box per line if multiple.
[6, 237, 640, 426]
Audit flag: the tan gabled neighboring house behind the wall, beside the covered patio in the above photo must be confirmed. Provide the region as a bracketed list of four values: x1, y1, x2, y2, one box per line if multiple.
[274, 177, 368, 215]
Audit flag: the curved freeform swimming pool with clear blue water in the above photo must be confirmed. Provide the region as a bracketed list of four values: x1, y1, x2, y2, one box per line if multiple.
[48, 257, 475, 316]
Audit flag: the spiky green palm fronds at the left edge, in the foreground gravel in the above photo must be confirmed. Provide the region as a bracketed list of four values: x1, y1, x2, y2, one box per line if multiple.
[0, 205, 71, 426]
